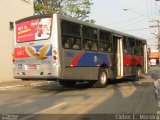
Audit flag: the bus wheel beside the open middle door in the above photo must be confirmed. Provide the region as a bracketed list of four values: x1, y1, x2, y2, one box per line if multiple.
[94, 68, 108, 88]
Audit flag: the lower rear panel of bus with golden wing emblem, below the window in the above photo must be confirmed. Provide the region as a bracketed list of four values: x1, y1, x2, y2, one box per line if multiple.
[14, 44, 58, 79]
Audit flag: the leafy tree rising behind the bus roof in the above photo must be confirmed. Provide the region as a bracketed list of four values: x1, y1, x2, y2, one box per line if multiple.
[34, 0, 95, 23]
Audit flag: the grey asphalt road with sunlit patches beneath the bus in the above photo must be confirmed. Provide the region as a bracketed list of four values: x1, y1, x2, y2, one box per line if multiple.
[0, 76, 159, 120]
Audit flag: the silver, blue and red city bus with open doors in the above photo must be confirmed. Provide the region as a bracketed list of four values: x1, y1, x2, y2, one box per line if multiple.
[13, 13, 147, 88]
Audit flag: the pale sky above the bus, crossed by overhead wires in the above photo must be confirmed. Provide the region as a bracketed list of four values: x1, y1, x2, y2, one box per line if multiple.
[90, 0, 160, 49]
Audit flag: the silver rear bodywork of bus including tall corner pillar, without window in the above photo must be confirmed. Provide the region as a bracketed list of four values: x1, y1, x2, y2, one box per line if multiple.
[14, 14, 59, 79]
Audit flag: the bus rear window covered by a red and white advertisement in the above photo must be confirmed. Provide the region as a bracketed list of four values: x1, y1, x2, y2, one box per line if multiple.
[16, 18, 52, 42]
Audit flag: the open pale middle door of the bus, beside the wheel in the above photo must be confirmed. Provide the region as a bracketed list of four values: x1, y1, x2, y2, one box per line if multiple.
[113, 36, 123, 79]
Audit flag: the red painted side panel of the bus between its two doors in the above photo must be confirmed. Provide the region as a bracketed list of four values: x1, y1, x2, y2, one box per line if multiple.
[123, 55, 143, 66]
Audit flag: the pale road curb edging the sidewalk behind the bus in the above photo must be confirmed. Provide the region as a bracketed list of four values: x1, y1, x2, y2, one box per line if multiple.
[0, 82, 48, 90]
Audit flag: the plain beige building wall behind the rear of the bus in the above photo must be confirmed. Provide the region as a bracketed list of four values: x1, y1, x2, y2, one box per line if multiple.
[0, 0, 34, 82]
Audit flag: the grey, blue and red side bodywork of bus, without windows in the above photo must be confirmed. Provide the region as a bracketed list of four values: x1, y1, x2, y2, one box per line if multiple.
[59, 16, 147, 80]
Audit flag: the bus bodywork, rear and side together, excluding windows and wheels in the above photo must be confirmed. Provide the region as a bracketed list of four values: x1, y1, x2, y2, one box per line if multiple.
[14, 14, 147, 81]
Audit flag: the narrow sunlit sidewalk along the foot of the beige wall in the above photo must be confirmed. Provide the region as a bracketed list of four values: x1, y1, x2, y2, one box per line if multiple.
[0, 80, 48, 90]
